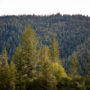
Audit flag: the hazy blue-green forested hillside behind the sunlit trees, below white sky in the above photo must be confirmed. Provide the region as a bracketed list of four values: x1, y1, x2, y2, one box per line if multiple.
[0, 14, 90, 74]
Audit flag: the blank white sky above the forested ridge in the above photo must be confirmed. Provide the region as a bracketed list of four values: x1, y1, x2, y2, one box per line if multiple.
[0, 0, 90, 16]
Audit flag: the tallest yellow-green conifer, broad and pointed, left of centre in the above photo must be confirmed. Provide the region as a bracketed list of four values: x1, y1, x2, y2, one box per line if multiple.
[14, 25, 38, 78]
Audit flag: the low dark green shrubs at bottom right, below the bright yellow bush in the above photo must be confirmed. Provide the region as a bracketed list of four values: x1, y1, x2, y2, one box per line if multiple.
[57, 78, 87, 90]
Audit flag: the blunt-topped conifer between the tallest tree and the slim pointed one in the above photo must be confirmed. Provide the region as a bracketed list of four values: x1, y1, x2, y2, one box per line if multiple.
[40, 46, 56, 90]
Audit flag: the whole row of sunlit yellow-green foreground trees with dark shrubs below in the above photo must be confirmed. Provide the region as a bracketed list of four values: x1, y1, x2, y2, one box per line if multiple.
[0, 25, 90, 90]
